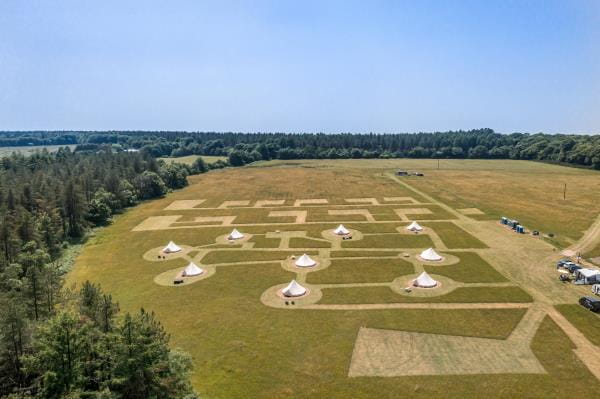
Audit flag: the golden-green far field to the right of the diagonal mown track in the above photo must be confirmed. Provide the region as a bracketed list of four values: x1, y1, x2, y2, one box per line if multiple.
[407, 161, 600, 247]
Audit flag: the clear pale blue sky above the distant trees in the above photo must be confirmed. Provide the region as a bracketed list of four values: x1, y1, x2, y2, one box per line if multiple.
[0, 0, 600, 133]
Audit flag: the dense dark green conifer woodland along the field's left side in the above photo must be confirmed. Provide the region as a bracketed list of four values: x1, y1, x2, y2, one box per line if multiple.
[0, 146, 202, 398]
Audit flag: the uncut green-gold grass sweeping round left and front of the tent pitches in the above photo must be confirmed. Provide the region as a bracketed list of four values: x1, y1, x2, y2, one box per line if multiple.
[67, 167, 597, 398]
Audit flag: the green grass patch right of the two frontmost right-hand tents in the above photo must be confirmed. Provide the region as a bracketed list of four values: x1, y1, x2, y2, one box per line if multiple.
[424, 252, 508, 283]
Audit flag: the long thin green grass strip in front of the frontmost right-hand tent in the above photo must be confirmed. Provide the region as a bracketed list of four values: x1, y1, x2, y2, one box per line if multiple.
[319, 287, 533, 304]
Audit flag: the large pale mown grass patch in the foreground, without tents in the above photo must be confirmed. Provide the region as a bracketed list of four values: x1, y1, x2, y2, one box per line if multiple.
[348, 309, 546, 377]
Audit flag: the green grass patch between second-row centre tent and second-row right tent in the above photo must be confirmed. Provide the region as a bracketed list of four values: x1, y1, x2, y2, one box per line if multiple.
[306, 258, 415, 284]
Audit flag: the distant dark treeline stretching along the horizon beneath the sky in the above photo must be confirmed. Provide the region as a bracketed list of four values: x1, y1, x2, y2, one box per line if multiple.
[0, 129, 600, 169]
